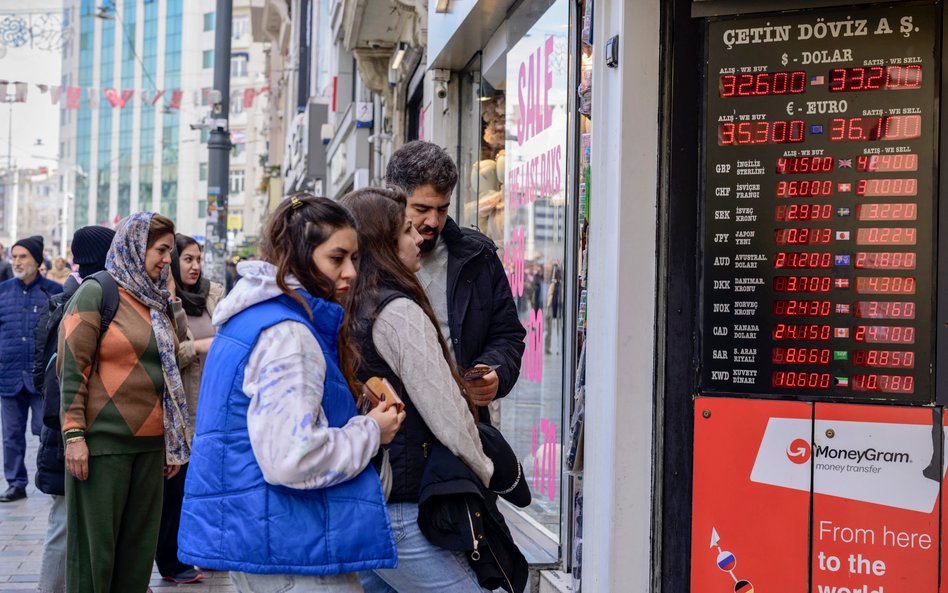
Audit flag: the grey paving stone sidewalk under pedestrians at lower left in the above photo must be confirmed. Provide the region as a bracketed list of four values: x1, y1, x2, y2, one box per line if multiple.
[0, 435, 234, 593]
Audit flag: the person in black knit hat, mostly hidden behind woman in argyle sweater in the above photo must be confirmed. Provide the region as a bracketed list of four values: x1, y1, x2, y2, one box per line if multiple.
[33, 226, 115, 593]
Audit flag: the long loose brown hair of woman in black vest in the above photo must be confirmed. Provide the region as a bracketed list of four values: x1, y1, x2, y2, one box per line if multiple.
[340, 187, 477, 420]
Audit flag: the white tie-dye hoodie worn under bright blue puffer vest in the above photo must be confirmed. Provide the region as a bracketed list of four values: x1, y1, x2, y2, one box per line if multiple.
[213, 261, 379, 489]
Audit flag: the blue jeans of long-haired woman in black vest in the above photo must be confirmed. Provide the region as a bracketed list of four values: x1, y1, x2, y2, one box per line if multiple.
[359, 503, 487, 593]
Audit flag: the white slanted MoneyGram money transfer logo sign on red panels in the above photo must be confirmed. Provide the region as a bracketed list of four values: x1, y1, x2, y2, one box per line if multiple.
[750, 418, 939, 513]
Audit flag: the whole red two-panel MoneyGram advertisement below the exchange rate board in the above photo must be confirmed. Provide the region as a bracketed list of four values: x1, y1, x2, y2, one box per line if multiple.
[692, 398, 944, 593]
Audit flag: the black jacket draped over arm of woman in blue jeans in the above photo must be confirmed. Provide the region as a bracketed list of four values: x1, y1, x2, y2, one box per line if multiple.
[418, 441, 529, 593]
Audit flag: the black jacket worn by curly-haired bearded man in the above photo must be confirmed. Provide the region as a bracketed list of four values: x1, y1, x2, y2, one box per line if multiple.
[441, 217, 527, 408]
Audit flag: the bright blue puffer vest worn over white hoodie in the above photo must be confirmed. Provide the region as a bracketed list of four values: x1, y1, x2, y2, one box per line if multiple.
[178, 290, 396, 575]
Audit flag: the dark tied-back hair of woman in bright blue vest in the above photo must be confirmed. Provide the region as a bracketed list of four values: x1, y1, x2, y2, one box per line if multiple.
[260, 192, 361, 398]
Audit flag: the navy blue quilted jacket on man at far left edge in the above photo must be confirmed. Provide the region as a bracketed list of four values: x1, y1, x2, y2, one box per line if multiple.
[0, 275, 63, 397]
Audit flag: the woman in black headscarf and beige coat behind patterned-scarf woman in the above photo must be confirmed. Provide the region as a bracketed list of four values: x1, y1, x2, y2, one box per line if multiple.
[155, 233, 224, 584]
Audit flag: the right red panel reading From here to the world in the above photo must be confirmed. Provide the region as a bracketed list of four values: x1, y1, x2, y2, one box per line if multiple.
[812, 404, 942, 593]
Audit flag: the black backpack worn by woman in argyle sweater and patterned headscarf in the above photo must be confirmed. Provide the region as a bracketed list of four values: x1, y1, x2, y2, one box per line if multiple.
[33, 271, 119, 495]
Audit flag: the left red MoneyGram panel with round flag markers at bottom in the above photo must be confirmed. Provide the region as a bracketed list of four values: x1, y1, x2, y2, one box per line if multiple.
[691, 398, 812, 593]
